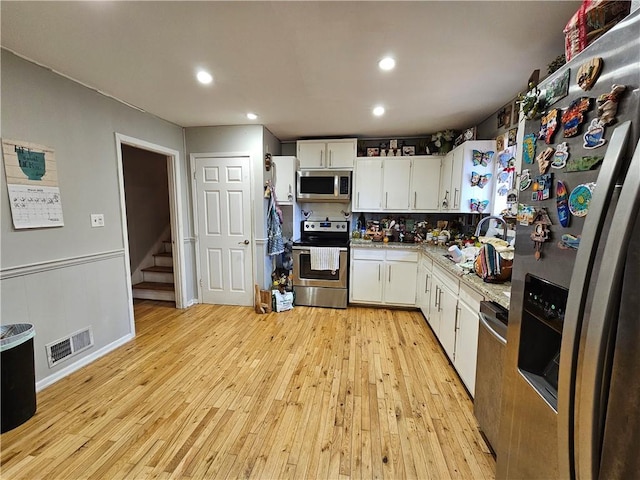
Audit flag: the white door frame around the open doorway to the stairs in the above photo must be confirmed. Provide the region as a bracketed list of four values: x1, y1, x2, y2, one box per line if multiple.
[115, 132, 188, 316]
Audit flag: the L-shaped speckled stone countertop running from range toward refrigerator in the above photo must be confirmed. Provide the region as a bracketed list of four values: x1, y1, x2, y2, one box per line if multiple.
[350, 239, 511, 309]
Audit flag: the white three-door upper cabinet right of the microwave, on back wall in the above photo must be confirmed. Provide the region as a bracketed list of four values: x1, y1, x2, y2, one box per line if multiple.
[353, 155, 441, 212]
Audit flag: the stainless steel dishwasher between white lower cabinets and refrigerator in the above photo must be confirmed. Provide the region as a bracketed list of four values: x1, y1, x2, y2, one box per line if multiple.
[473, 301, 509, 455]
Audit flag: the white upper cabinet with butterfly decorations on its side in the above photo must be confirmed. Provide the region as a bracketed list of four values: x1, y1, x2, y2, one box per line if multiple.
[440, 140, 497, 213]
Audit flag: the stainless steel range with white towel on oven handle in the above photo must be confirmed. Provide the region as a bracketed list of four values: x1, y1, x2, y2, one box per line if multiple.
[293, 219, 349, 308]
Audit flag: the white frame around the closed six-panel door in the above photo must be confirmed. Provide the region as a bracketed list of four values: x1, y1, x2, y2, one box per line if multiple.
[189, 152, 257, 303]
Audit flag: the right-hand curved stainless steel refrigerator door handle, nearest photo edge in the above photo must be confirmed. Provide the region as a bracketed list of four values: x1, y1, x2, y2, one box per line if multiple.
[575, 141, 640, 478]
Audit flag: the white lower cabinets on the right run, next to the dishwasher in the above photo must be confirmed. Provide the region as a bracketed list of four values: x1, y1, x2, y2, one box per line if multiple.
[423, 265, 484, 397]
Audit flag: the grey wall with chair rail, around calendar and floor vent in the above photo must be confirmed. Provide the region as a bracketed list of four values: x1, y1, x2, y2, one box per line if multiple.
[0, 51, 190, 387]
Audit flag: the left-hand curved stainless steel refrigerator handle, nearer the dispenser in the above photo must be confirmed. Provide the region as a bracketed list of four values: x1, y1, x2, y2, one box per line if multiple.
[558, 121, 631, 478]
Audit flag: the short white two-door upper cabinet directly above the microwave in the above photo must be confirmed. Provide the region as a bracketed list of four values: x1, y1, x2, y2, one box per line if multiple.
[297, 138, 357, 170]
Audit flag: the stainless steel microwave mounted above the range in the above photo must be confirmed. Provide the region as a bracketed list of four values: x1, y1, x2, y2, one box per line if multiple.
[296, 170, 351, 203]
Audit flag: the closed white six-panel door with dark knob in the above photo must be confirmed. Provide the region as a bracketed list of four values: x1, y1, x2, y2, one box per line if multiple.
[195, 157, 253, 305]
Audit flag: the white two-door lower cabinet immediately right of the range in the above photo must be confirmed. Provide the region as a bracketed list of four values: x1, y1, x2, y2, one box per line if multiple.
[349, 248, 418, 307]
